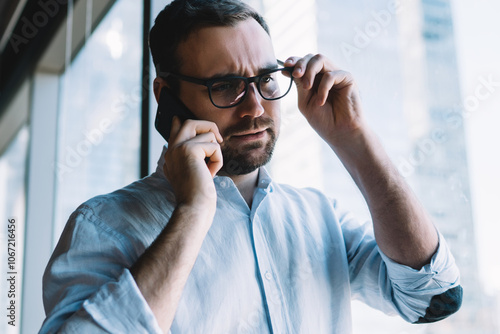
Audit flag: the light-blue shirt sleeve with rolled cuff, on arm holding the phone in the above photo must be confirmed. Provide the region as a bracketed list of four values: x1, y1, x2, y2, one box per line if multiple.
[40, 207, 162, 334]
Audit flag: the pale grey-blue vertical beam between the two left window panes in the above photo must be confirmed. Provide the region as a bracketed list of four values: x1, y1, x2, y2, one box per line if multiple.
[21, 73, 59, 333]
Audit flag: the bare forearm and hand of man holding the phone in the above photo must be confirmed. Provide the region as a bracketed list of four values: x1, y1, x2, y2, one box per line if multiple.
[130, 118, 222, 333]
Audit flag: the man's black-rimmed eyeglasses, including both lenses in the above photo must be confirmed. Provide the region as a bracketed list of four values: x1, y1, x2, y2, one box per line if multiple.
[163, 61, 294, 108]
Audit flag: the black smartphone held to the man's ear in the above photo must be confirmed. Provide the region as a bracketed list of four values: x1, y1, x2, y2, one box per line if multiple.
[155, 87, 196, 142]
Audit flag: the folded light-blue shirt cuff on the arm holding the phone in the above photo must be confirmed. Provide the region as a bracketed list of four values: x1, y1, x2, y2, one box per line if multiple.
[83, 269, 163, 334]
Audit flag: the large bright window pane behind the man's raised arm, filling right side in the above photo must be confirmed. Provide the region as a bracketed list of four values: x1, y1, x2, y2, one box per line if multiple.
[263, 0, 500, 334]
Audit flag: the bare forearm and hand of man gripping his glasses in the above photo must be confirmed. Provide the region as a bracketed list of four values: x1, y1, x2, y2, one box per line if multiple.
[285, 55, 438, 269]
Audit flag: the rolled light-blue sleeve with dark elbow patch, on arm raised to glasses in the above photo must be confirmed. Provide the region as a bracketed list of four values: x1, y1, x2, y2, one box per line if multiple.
[340, 202, 462, 323]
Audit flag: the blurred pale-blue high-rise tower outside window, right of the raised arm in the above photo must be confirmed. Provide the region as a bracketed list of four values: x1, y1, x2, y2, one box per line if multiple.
[399, 0, 498, 334]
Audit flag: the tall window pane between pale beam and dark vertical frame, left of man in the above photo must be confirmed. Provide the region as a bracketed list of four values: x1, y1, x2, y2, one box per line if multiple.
[54, 0, 142, 241]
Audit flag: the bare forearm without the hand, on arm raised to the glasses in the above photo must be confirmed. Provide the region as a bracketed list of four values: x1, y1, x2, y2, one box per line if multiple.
[334, 126, 438, 269]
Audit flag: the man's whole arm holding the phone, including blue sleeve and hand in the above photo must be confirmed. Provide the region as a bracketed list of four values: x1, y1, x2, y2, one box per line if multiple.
[40, 116, 220, 333]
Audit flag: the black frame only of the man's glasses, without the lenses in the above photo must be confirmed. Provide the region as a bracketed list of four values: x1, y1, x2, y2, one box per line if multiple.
[162, 60, 294, 109]
